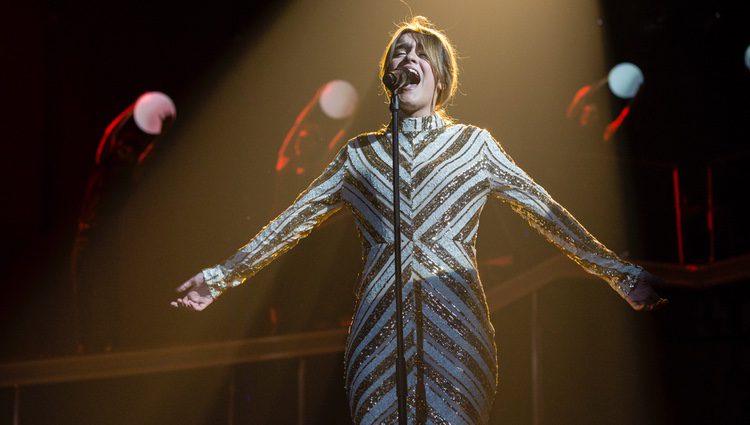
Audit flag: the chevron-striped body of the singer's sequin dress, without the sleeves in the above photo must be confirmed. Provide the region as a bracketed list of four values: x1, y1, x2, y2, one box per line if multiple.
[344, 117, 497, 424]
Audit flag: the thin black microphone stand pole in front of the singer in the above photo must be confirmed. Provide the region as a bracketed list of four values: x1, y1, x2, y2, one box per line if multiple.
[390, 90, 407, 425]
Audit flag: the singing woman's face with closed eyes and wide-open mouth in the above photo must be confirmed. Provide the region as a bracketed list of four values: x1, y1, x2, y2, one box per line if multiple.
[388, 33, 437, 117]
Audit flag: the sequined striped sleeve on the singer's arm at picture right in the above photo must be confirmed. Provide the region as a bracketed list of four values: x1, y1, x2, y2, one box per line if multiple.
[481, 130, 643, 309]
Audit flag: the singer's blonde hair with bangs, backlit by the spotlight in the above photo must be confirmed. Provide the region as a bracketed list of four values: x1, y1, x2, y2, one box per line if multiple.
[380, 16, 458, 120]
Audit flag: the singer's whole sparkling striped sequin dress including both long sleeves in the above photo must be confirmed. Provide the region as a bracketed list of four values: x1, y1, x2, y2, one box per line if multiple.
[204, 116, 642, 424]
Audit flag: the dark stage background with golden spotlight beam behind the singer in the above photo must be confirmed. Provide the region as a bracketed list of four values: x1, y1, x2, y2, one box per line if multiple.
[0, 0, 750, 424]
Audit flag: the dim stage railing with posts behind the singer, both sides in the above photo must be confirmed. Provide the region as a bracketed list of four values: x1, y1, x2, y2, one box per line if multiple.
[0, 254, 750, 424]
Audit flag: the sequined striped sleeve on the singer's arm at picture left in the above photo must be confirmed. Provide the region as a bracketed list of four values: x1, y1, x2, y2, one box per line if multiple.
[203, 146, 347, 298]
